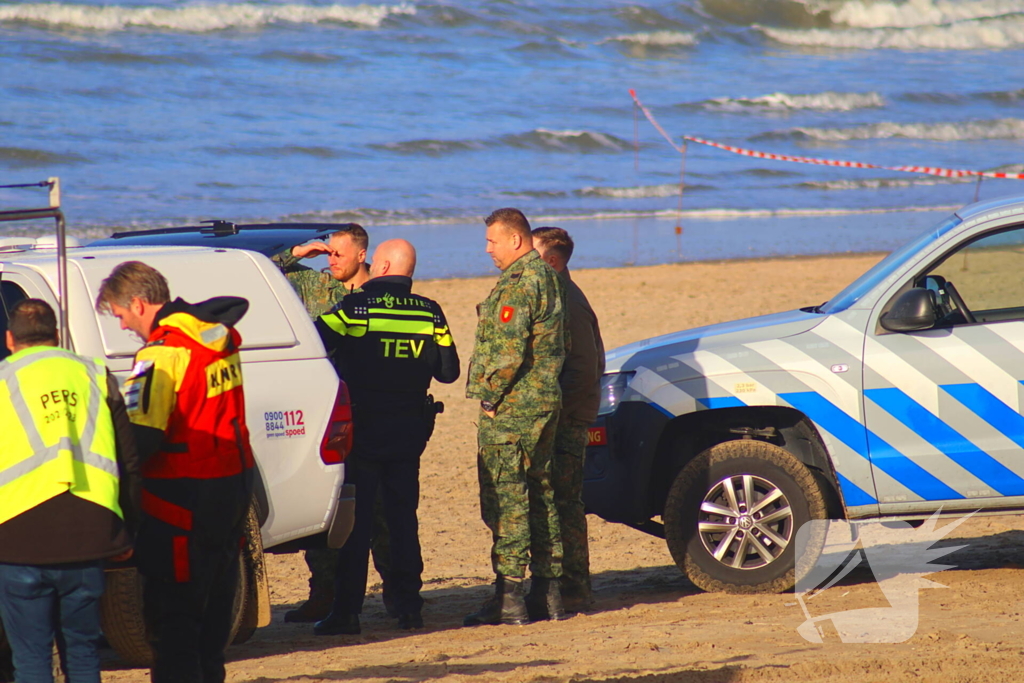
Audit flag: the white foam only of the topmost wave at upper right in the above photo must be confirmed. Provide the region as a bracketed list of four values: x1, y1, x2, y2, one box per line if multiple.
[815, 0, 1024, 29]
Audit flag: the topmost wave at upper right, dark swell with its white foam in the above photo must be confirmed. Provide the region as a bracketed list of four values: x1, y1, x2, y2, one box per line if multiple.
[701, 0, 1024, 29]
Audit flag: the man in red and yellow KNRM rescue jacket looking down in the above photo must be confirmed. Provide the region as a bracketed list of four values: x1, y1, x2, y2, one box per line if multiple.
[96, 261, 253, 683]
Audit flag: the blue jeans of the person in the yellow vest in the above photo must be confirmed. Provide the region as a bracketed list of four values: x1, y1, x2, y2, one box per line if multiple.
[0, 562, 103, 683]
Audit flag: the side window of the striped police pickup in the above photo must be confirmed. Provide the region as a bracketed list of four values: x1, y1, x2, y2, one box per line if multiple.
[919, 225, 1024, 325]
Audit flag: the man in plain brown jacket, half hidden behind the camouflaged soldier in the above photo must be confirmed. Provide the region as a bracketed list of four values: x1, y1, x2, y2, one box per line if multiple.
[534, 227, 604, 612]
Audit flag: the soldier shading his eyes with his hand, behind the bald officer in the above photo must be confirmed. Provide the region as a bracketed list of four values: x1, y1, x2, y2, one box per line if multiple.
[272, 223, 391, 623]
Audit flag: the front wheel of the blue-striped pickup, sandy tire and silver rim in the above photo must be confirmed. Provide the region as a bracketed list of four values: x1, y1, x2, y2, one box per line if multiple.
[664, 439, 827, 593]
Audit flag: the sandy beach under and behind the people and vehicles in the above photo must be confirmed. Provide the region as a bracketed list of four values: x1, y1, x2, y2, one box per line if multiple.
[97, 254, 1024, 683]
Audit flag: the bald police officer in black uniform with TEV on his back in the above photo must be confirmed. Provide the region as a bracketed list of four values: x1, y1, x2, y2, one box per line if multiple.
[313, 240, 459, 635]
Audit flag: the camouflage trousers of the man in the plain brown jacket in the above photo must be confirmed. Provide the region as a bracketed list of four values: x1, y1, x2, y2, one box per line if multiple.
[551, 418, 590, 596]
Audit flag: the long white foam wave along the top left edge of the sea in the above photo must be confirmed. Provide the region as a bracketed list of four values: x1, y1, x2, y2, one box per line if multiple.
[0, 3, 416, 33]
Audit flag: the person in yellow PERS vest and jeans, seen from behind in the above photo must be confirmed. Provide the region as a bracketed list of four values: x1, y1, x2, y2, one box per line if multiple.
[0, 299, 138, 683]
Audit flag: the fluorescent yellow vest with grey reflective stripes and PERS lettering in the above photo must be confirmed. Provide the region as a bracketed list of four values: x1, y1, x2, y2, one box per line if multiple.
[0, 346, 124, 524]
